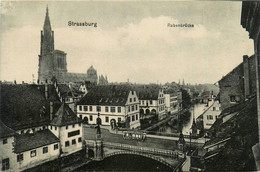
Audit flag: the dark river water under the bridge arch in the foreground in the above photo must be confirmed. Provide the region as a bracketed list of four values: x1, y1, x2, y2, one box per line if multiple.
[75, 155, 172, 172]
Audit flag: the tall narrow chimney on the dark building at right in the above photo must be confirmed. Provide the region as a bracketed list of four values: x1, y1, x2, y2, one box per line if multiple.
[243, 55, 250, 99]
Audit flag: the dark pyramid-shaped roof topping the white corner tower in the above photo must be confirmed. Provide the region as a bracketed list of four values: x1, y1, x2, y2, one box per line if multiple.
[50, 103, 82, 126]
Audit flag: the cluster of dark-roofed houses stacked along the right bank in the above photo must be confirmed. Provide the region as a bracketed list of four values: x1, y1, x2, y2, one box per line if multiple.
[191, 55, 258, 171]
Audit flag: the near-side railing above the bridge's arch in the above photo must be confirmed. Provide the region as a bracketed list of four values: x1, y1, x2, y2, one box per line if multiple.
[103, 142, 178, 158]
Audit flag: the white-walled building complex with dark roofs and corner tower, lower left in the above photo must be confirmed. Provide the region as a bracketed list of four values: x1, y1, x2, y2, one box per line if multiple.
[0, 84, 83, 171]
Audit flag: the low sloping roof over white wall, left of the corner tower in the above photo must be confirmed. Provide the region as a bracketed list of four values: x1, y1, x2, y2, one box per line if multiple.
[14, 129, 59, 153]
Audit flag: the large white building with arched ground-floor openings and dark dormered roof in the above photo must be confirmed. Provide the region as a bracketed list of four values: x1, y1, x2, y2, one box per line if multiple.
[77, 85, 140, 129]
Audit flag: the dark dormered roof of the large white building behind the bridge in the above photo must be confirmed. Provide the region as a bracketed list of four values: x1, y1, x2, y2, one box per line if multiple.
[77, 85, 132, 106]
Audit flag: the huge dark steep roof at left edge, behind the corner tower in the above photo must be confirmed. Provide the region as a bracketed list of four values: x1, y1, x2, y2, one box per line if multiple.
[0, 84, 60, 130]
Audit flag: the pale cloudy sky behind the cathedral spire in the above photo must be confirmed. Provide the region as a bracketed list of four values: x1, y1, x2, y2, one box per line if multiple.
[0, 1, 254, 84]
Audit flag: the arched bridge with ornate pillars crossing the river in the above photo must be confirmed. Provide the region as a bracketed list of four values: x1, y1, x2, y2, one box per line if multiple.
[83, 125, 204, 171]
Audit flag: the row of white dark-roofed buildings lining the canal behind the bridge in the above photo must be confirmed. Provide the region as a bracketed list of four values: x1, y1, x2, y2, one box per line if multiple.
[77, 84, 181, 129]
